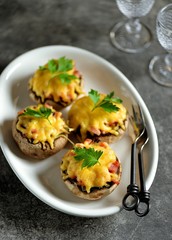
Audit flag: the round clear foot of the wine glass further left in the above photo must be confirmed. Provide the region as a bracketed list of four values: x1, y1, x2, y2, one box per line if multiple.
[110, 21, 153, 53]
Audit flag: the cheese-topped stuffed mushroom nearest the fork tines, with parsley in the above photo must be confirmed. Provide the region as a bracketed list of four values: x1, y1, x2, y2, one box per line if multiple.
[68, 90, 128, 143]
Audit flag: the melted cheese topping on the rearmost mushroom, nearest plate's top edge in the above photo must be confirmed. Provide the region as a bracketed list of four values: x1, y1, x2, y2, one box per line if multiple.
[29, 60, 82, 103]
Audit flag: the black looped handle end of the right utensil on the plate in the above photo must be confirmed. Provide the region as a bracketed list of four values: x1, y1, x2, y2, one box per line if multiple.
[135, 191, 150, 217]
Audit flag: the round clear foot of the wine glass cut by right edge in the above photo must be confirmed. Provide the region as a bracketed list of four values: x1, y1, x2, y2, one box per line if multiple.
[149, 54, 172, 87]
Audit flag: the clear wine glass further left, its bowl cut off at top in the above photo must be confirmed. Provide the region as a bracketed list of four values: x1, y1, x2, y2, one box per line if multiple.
[110, 0, 155, 53]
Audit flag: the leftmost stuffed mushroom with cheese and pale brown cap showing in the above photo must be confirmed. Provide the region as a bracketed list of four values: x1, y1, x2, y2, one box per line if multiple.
[12, 104, 69, 159]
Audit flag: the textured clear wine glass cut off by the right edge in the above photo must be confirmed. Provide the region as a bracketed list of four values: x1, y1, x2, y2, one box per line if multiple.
[149, 4, 172, 87]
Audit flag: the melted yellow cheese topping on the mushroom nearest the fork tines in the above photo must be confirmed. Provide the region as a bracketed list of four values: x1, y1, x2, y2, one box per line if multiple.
[69, 94, 127, 141]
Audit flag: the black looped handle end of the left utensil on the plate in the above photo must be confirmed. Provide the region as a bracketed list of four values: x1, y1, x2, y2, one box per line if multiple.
[122, 184, 140, 211]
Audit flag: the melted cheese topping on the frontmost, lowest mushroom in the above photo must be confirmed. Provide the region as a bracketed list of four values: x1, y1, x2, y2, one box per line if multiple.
[61, 142, 121, 193]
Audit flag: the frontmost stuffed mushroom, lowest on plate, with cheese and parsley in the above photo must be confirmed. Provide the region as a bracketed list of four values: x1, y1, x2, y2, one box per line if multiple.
[60, 139, 122, 200]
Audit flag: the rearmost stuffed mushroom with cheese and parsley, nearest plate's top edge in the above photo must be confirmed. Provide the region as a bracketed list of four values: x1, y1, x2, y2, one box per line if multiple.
[29, 57, 83, 110]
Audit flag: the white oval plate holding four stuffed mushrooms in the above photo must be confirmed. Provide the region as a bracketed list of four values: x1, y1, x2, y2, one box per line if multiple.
[0, 46, 158, 217]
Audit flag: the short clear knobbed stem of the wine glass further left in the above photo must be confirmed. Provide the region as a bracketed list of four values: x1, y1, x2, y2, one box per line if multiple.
[125, 18, 142, 34]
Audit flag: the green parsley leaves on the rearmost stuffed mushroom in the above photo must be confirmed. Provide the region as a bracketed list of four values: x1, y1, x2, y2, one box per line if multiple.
[39, 57, 76, 84]
